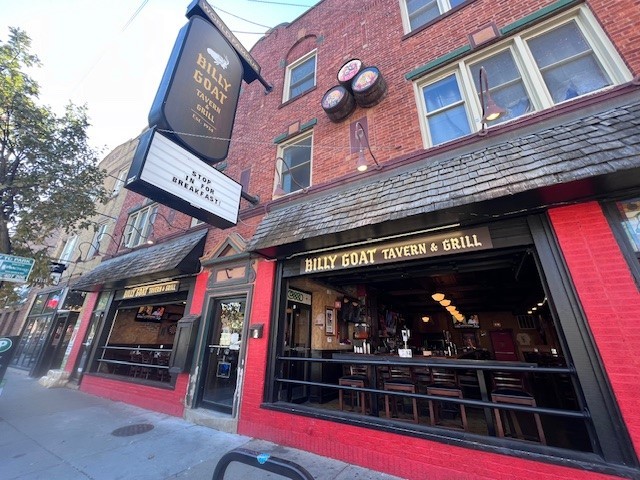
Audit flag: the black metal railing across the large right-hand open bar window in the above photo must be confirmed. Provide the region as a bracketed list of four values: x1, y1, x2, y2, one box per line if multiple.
[268, 354, 592, 451]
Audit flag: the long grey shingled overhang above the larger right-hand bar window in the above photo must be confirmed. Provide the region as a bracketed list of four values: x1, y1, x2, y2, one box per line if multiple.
[248, 90, 640, 258]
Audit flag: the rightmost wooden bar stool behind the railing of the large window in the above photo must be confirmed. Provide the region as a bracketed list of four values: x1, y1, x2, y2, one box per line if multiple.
[491, 372, 547, 445]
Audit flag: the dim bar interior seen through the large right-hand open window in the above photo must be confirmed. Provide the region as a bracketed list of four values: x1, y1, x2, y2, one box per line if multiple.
[279, 248, 593, 451]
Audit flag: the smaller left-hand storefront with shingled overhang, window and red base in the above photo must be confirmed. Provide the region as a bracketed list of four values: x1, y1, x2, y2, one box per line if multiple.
[70, 230, 206, 416]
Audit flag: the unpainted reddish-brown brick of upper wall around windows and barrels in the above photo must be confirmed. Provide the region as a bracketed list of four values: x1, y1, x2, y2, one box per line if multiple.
[214, 0, 640, 214]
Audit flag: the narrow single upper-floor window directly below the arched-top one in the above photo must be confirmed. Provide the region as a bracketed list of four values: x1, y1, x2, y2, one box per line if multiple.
[275, 135, 313, 194]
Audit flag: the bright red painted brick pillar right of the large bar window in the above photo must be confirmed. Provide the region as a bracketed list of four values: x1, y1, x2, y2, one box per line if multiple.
[549, 202, 640, 454]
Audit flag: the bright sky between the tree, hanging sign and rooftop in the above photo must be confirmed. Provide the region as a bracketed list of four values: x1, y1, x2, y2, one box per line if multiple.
[0, 0, 318, 156]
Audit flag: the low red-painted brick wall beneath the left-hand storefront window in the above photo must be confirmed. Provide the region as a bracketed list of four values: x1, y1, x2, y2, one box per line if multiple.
[80, 373, 189, 417]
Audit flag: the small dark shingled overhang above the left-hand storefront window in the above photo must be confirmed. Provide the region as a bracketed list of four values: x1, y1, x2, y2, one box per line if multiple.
[71, 230, 207, 292]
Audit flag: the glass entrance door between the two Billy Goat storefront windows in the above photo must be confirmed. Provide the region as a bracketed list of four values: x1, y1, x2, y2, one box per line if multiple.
[200, 297, 247, 413]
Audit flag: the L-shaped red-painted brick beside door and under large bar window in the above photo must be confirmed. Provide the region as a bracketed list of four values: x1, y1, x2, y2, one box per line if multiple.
[238, 261, 624, 480]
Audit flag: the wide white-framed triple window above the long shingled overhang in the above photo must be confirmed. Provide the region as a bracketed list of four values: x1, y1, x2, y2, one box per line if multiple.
[416, 6, 631, 146]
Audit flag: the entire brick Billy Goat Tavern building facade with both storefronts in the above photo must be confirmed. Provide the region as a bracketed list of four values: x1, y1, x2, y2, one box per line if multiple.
[66, 0, 640, 479]
